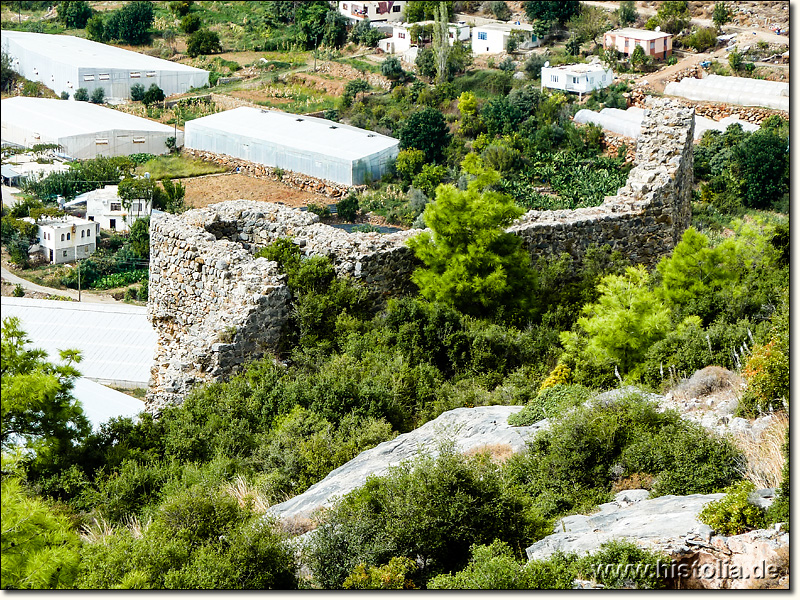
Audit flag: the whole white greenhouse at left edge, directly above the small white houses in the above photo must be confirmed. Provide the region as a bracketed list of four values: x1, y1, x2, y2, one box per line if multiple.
[0, 96, 183, 159]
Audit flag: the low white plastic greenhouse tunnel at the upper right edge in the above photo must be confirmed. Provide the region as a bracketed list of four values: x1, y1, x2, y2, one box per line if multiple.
[664, 75, 789, 112]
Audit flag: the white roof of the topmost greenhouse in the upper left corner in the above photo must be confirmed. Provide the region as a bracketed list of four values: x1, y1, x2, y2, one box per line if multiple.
[2, 30, 204, 73]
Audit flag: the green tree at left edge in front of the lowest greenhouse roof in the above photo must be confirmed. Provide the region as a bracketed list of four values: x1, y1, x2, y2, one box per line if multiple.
[0, 317, 89, 458]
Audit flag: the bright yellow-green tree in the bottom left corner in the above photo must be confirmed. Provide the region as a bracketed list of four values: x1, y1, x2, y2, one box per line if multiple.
[0, 468, 80, 590]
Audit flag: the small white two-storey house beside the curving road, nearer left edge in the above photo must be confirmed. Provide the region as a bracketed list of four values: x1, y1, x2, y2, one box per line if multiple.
[25, 217, 100, 264]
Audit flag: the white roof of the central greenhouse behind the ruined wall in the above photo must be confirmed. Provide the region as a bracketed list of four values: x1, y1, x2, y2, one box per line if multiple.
[186, 106, 399, 160]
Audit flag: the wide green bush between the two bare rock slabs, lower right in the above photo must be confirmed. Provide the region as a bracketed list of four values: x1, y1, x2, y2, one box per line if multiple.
[507, 395, 741, 516]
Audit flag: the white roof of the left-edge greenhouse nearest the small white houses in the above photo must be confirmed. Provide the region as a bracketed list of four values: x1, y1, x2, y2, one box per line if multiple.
[0, 96, 173, 139]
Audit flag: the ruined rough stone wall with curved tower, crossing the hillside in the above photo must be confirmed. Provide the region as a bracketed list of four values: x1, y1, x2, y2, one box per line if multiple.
[146, 100, 694, 412]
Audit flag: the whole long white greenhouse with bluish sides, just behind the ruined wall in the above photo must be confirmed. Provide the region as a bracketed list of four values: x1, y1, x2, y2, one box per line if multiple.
[186, 106, 399, 185]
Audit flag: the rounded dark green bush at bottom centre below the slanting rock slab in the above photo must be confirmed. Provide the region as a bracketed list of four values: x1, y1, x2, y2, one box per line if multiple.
[309, 448, 548, 589]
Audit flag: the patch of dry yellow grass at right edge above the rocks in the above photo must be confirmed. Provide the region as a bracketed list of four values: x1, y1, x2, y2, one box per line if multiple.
[732, 412, 789, 489]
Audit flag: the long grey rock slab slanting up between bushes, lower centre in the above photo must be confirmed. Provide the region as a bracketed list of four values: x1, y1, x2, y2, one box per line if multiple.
[268, 406, 547, 520]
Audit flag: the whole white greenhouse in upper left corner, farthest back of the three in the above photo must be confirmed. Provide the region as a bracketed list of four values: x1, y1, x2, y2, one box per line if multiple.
[1, 30, 208, 100]
